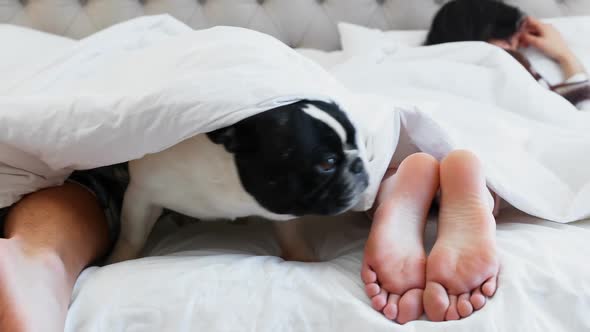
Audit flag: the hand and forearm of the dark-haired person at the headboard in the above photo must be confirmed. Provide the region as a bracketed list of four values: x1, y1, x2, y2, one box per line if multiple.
[520, 17, 586, 81]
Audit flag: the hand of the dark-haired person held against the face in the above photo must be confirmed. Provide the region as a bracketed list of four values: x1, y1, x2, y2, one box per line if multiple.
[520, 17, 574, 63]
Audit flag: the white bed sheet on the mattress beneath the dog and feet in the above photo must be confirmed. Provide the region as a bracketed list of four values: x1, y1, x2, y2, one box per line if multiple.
[66, 45, 590, 332]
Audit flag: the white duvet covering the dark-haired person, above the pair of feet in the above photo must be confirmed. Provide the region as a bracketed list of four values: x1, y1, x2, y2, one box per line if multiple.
[332, 42, 590, 222]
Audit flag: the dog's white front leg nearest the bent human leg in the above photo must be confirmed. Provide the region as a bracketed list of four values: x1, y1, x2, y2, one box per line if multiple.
[108, 184, 163, 263]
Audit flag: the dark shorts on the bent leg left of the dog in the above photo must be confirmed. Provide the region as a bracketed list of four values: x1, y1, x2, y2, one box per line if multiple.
[0, 163, 129, 242]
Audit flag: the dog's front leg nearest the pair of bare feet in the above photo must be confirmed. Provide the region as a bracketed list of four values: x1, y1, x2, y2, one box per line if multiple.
[273, 220, 318, 262]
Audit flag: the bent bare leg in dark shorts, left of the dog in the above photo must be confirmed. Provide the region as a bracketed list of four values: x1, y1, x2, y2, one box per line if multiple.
[0, 166, 126, 332]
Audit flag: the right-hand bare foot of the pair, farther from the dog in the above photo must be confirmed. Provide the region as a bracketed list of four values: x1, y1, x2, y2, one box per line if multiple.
[424, 151, 499, 321]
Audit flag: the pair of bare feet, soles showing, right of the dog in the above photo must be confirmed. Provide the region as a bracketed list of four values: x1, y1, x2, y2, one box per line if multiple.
[361, 150, 499, 324]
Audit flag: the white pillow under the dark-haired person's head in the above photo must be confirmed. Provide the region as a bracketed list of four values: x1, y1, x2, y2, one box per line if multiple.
[338, 16, 590, 84]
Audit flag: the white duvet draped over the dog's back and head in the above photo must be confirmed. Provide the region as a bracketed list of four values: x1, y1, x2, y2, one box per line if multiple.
[0, 16, 398, 209]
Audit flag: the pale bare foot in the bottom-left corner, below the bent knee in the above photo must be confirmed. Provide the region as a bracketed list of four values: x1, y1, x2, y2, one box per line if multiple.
[0, 238, 74, 332]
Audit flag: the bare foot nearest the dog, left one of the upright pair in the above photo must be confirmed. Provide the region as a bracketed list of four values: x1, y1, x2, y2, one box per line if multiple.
[361, 153, 439, 324]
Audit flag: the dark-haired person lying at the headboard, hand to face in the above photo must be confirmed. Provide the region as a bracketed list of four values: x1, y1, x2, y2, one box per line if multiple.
[425, 0, 590, 110]
